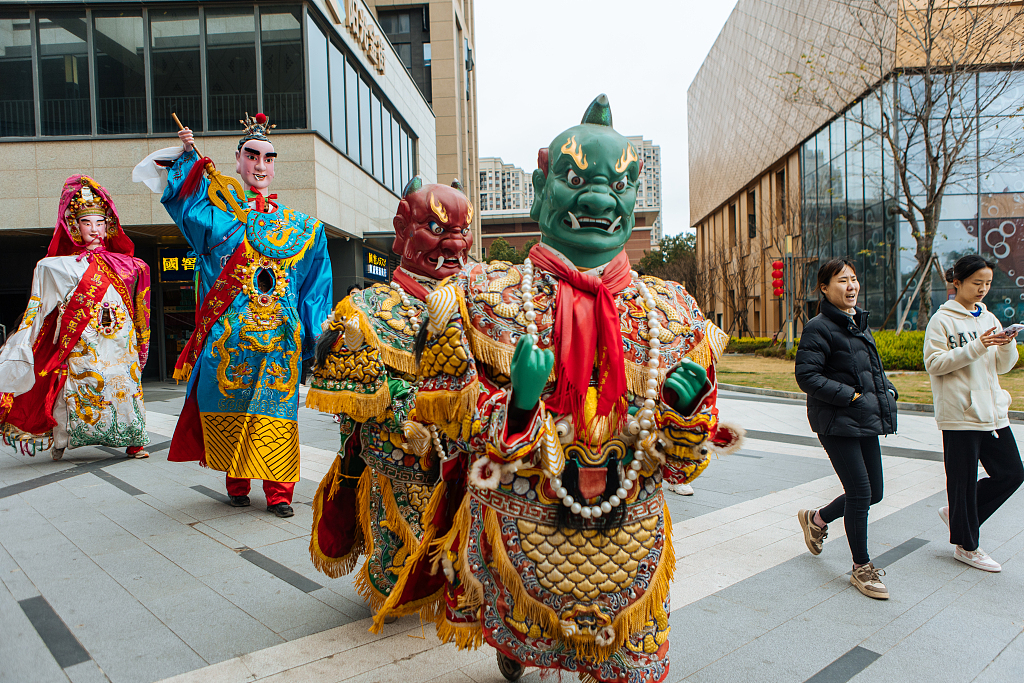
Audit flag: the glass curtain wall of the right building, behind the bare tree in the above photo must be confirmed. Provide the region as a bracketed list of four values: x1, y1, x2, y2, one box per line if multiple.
[800, 72, 1024, 330]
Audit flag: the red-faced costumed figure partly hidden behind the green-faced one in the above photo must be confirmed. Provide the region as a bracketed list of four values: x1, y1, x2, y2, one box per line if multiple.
[306, 176, 473, 621]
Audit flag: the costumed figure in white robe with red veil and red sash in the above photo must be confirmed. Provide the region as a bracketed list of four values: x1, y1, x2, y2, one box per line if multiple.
[0, 175, 150, 460]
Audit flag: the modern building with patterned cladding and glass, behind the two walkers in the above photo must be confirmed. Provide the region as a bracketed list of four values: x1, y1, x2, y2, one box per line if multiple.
[687, 0, 1024, 336]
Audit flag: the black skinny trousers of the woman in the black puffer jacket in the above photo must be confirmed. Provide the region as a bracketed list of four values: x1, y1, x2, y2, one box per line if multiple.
[818, 434, 882, 564]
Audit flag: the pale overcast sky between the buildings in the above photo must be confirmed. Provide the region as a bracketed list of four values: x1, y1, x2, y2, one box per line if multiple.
[474, 0, 735, 239]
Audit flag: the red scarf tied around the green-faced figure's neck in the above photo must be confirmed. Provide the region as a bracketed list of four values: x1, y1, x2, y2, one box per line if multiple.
[529, 245, 632, 431]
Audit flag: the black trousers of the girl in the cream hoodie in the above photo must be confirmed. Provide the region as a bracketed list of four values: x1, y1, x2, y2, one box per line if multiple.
[942, 427, 1024, 550]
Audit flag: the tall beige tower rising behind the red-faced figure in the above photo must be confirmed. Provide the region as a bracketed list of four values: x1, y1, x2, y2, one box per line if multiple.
[367, 0, 481, 258]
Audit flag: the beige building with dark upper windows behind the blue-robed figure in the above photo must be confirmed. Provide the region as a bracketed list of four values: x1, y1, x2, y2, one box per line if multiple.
[0, 0, 437, 378]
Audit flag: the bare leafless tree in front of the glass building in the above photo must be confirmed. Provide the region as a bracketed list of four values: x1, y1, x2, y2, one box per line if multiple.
[783, 0, 1024, 330]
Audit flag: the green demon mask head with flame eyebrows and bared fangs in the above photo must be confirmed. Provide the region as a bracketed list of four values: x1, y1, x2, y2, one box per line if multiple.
[529, 94, 641, 268]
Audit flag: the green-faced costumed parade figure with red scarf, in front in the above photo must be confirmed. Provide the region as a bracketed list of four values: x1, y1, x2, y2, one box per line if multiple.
[374, 95, 740, 683]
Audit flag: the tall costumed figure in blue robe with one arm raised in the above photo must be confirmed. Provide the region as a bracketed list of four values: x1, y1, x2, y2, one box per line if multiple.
[134, 114, 332, 517]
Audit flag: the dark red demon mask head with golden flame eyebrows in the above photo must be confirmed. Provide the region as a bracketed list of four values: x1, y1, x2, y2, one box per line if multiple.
[393, 176, 473, 280]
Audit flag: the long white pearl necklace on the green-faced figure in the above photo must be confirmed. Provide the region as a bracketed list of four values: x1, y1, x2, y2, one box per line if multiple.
[520, 258, 662, 519]
